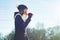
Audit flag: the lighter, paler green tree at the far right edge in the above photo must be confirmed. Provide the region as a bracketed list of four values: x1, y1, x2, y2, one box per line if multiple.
[47, 26, 60, 40]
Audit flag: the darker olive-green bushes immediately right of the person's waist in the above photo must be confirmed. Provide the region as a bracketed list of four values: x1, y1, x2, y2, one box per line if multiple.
[27, 29, 45, 40]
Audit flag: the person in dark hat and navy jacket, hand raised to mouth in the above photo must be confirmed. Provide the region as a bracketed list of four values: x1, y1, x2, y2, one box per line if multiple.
[14, 5, 32, 40]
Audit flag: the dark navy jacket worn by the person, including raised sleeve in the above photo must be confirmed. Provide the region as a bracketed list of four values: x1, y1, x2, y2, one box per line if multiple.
[14, 12, 32, 40]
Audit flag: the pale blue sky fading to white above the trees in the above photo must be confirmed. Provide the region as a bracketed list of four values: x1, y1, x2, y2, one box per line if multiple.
[0, 0, 60, 35]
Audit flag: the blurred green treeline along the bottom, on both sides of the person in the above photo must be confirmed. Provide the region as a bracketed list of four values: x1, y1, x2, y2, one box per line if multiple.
[0, 26, 60, 40]
